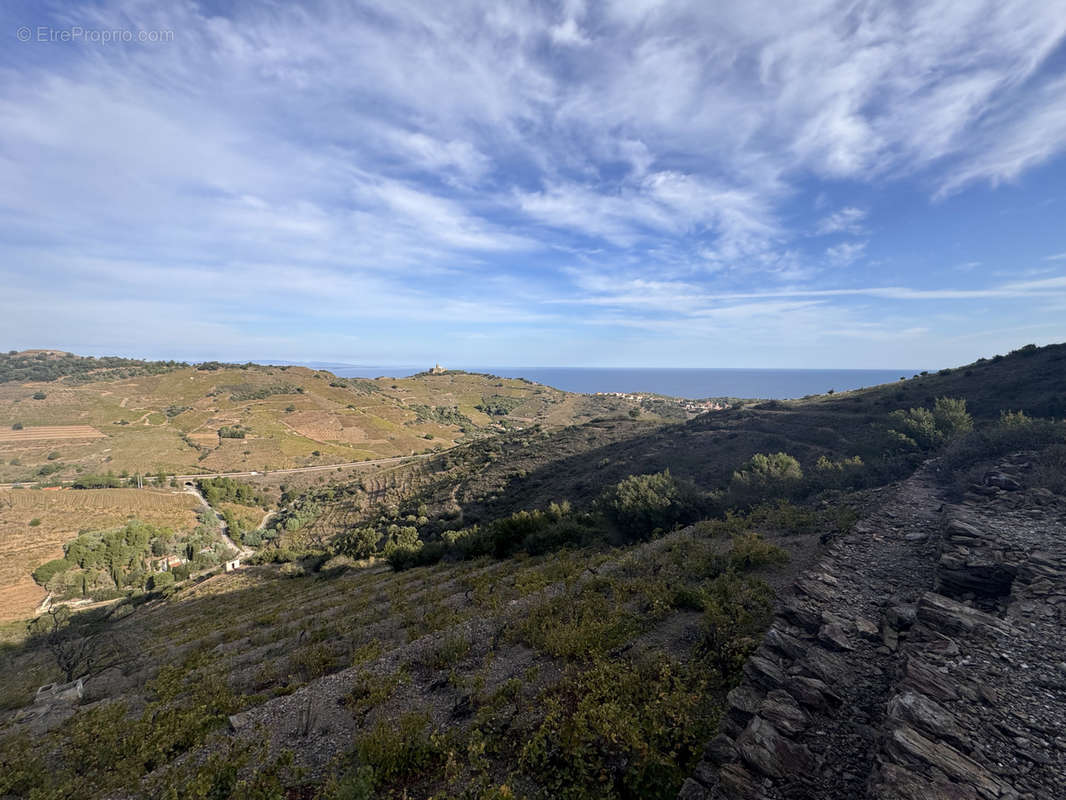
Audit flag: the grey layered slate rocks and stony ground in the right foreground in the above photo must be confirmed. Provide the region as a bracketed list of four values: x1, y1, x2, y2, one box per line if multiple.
[679, 453, 1066, 800]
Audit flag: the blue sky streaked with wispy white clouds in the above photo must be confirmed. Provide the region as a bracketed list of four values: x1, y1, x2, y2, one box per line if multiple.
[0, 0, 1066, 368]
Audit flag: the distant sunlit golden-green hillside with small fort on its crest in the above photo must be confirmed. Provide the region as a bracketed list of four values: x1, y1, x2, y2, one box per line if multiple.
[0, 351, 687, 483]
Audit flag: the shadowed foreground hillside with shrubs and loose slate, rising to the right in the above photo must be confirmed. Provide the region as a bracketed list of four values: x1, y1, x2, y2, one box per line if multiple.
[0, 346, 1066, 800]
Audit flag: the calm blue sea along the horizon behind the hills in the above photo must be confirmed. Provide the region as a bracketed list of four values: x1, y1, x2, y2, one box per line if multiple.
[323, 365, 919, 400]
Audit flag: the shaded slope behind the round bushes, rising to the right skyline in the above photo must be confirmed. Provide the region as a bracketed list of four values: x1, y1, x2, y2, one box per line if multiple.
[262, 345, 1066, 558]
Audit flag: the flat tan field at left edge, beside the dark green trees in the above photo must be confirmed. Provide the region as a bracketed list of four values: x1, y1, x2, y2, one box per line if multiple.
[0, 489, 199, 622]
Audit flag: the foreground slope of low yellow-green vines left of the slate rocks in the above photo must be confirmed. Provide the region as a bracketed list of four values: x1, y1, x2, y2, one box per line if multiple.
[0, 520, 797, 798]
